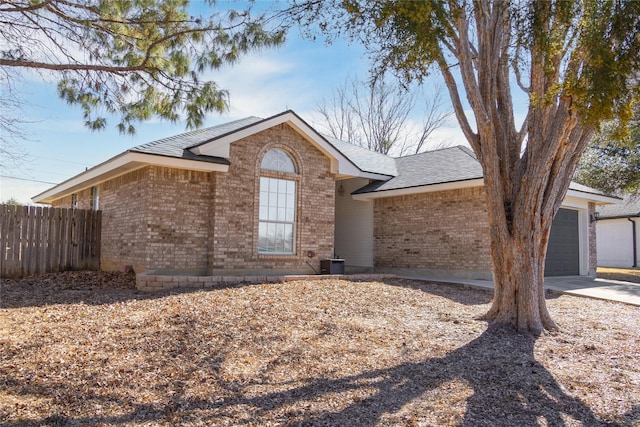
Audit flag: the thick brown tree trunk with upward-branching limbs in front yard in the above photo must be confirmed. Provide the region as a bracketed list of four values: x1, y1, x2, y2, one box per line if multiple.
[438, 0, 593, 334]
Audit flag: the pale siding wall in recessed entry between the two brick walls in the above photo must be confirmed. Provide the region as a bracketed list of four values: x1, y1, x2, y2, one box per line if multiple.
[335, 178, 373, 267]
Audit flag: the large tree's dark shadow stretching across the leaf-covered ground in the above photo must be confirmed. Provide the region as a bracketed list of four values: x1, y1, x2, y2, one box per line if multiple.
[5, 330, 640, 426]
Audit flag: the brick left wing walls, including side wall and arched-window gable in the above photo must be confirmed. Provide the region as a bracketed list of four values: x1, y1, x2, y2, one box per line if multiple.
[52, 125, 335, 274]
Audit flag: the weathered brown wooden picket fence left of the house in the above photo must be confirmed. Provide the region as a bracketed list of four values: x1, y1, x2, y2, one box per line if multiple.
[0, 205, 102, 277]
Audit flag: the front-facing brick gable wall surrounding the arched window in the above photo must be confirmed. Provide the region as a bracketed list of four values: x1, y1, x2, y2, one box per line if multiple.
[209, 124, 335, 273]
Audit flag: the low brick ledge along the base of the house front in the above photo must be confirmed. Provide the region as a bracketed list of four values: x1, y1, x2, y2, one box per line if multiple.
[136, 273, 396, 292]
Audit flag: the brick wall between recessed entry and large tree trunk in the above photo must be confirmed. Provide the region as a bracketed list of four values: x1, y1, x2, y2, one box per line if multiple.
[374, 188, 491, 277]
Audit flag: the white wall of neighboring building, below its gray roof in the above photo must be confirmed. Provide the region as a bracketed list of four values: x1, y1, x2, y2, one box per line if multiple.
[596, 218, 640, 267]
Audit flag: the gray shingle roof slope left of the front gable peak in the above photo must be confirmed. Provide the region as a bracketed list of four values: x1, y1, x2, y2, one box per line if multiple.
[128, 117, 262, 164]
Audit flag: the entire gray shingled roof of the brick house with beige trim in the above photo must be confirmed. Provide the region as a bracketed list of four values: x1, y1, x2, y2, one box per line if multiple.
[34, 111, 610, 202]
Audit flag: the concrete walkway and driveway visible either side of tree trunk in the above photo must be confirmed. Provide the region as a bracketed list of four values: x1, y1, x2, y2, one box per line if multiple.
[402, 276, 640, 307]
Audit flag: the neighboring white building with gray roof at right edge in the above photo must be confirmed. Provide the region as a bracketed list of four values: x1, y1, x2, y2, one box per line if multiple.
[596, 194, 640, 268]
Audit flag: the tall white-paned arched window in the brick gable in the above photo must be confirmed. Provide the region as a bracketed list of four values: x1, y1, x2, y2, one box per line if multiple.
[258, 149, 297, 255]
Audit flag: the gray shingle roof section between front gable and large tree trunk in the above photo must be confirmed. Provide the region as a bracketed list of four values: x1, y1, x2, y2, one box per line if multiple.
[354, 146, 482, 194]
